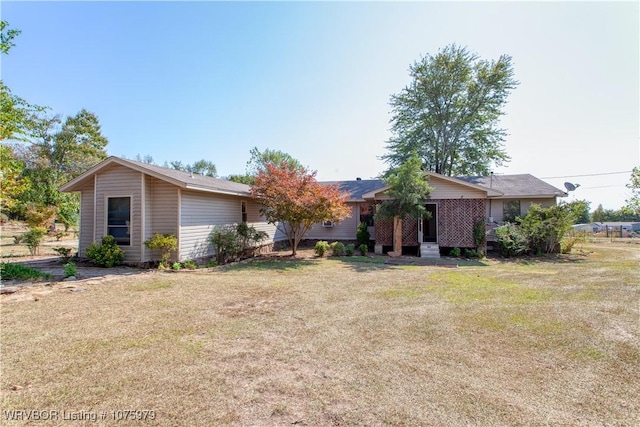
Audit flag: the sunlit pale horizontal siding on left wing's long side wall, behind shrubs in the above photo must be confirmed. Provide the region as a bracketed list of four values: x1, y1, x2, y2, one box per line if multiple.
[179, 191, 245, 260]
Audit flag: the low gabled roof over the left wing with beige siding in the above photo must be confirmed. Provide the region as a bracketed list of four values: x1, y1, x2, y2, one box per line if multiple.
[60, 156, 250, 196]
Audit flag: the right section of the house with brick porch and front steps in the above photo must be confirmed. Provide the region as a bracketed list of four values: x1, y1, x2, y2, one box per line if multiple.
[306, 172, 567, 255]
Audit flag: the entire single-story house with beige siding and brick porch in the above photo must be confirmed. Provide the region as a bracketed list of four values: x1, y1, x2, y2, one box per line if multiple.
[61, 157, 566, 263]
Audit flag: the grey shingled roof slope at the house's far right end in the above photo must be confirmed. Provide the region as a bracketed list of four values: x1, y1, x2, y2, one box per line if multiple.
[458, 174, 567, 198]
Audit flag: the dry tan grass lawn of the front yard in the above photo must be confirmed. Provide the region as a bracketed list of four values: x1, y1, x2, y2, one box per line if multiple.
[0, 242, 640, 426]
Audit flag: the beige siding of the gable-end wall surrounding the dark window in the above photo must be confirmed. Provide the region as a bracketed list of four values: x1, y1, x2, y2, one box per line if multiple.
[95, 165, 142, 263]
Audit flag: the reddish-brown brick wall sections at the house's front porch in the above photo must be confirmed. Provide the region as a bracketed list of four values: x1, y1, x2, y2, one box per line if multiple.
[375, 199, 485, 248]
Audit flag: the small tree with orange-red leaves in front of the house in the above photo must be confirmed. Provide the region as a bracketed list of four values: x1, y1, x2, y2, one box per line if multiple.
[251, 162, 351, 256]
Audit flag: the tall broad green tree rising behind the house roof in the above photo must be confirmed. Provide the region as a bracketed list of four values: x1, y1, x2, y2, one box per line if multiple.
[383, 44, 518, 176]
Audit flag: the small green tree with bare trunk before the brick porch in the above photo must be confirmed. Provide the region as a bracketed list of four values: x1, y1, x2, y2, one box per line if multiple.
[375, 153, 431, 255]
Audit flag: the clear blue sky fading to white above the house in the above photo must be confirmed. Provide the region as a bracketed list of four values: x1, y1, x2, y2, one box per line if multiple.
[0, 1, 640, 209]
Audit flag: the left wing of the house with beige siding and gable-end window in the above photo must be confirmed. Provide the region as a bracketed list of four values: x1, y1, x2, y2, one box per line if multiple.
[60, 157, 284, 264]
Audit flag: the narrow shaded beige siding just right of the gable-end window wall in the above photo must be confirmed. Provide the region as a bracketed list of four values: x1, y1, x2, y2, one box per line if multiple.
[142, 175, 180, 261]
